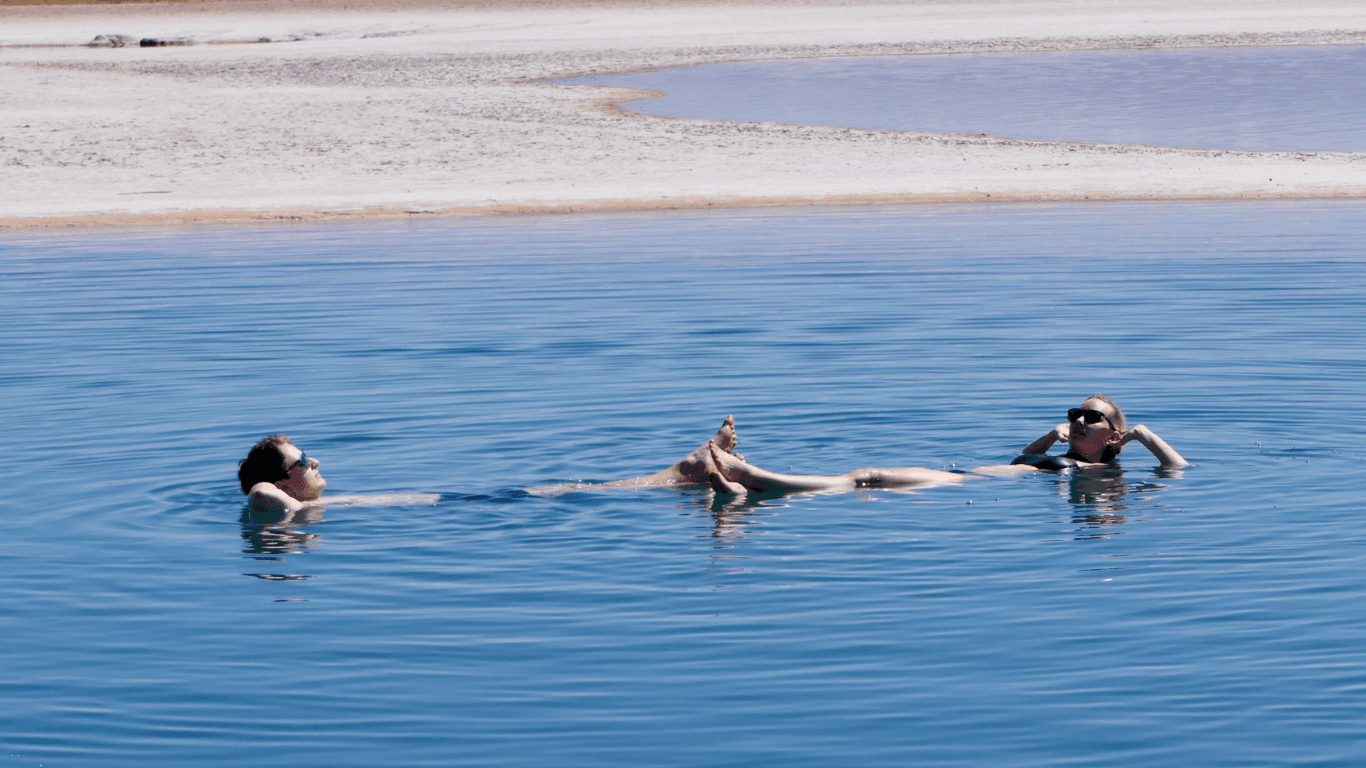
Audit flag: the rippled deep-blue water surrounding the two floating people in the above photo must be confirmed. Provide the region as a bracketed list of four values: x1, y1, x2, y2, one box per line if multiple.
[0, 202, 1366, 768]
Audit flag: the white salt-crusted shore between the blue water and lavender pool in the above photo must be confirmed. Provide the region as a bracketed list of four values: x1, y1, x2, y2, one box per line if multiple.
[0, 0, 1366, 227]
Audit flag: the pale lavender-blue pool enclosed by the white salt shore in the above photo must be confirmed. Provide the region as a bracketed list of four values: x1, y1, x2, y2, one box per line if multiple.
[568, 46, 1366, 152]
